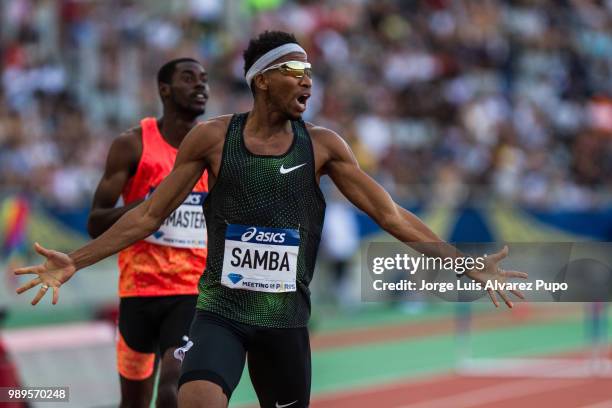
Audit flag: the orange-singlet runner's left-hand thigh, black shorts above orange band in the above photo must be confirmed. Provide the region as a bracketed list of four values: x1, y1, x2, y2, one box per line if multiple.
[117, 297, 159, 381]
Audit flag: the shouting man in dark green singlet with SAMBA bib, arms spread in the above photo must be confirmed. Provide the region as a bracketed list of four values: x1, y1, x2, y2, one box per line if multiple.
[16, 31, 526, 408]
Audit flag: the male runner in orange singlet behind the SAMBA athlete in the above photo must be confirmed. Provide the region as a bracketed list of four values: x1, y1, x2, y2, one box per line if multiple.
[88, 58, 208, 408]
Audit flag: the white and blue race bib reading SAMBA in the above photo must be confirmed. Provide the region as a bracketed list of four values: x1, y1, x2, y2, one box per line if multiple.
[221, 224, 300, 293]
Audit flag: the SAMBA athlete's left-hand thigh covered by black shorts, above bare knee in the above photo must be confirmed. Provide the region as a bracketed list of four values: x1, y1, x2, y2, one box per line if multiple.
[179, 310, 246, 400]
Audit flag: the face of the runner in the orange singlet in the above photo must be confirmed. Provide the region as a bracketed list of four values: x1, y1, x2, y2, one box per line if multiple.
[170, 62, 209, 116]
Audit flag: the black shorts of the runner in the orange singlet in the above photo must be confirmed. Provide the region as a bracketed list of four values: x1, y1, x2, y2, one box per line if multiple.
[119, 295, 198, 356]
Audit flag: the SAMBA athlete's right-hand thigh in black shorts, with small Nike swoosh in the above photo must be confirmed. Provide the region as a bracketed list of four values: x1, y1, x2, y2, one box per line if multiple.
[248, 328, 311, 408]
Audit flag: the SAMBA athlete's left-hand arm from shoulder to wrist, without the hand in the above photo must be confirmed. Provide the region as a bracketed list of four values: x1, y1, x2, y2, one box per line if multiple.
[69, 123, 219, 270]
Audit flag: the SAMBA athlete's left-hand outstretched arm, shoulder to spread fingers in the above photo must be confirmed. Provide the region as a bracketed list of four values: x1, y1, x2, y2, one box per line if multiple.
[15, 123, 219, 304]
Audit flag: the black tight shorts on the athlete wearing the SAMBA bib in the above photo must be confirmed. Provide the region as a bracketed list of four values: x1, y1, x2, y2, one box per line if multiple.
[179, 310, 311, 408]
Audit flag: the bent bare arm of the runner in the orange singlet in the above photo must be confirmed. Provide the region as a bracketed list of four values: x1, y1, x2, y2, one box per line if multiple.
[87, 129, 143, 238]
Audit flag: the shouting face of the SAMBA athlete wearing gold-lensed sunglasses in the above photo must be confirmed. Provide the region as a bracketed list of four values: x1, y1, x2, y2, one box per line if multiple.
[262, 52, 312, 120]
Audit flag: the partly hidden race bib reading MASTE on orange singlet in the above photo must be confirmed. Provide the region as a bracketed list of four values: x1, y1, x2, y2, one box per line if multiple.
[145, 189, 207, 249]
